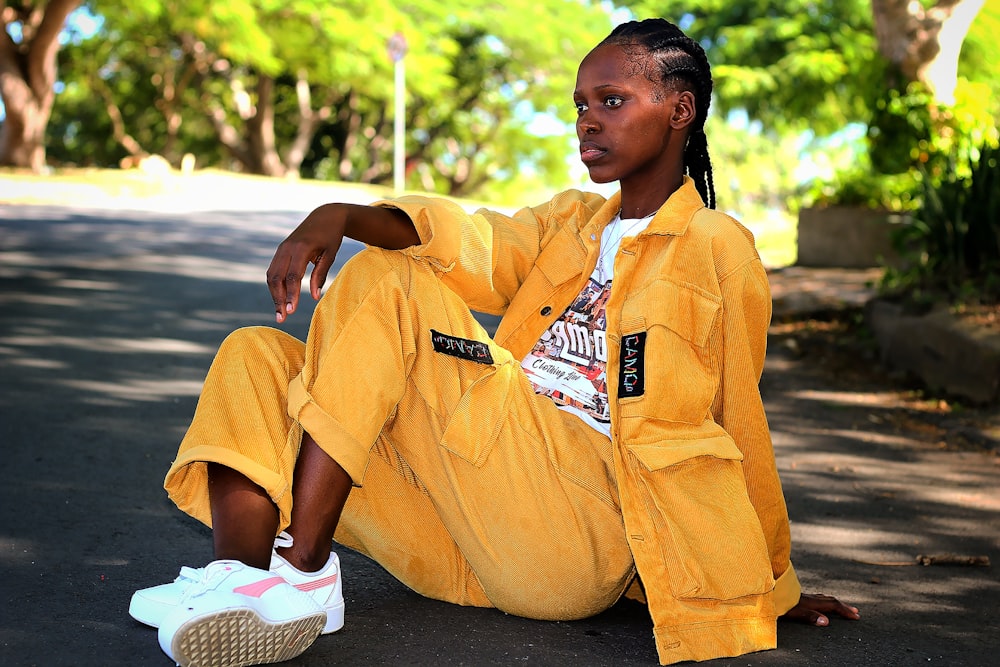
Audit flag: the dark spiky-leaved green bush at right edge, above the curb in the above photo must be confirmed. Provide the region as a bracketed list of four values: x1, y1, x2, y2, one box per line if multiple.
[881, 143, 1000, 305]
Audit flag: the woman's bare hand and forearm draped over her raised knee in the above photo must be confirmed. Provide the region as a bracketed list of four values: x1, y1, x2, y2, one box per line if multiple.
[267, 204, 420, 323]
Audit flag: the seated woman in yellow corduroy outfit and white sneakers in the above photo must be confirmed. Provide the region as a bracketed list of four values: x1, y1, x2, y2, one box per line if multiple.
[130, 19, 858, 665]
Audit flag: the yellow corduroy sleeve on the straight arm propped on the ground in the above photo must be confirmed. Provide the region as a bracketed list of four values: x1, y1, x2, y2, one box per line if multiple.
[713, 258, 801, 616]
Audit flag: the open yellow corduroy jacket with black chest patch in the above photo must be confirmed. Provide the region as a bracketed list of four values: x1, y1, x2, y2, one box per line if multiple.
[377, 178, 800, 664]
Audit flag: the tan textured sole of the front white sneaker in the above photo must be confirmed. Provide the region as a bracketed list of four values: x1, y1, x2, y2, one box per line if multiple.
[170, 609, 327, 667]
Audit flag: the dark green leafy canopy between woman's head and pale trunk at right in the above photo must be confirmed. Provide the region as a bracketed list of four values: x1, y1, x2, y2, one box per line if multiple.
[624, 0, 880, 135]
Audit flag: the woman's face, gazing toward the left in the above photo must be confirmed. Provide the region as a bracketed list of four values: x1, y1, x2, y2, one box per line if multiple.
[573, 44, 684, 191]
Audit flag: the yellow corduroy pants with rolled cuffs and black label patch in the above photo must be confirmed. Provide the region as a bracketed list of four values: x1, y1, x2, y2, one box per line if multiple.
[165, 249, 634, 620]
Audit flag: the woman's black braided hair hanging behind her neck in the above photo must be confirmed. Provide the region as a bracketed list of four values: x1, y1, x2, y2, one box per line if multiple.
[601, 19, 715, 208]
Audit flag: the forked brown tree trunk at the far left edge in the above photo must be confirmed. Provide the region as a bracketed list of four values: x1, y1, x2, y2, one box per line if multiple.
[0, 0, 80, 172]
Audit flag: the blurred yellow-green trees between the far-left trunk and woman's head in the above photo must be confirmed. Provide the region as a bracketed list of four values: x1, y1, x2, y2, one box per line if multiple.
[50, 0, 611, 195]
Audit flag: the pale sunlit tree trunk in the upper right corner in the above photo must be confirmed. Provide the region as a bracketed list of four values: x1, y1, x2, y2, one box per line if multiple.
[872, 0, 986, 105]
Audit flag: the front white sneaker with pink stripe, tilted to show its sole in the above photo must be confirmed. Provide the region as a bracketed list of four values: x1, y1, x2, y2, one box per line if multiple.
[158, 560, 326, 667]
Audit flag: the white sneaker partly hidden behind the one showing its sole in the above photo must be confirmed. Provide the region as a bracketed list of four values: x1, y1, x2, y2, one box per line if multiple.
[128, 532, 344, 634]
